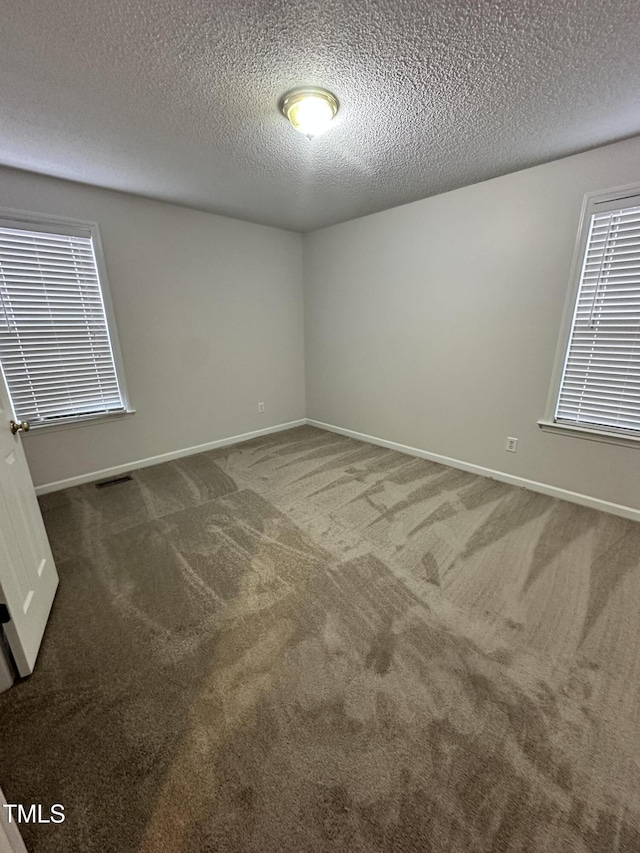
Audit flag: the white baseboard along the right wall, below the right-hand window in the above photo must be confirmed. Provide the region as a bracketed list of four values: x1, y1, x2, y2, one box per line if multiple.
[307, 418, 640, 521]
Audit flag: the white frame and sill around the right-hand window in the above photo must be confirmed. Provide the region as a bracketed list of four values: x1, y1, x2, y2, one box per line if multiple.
[538, 183, 640, 447]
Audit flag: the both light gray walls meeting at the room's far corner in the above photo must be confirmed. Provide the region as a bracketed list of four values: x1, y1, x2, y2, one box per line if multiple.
[5, 133, 640, 508]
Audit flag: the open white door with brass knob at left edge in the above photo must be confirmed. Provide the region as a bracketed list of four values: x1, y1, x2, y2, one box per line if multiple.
[0, 370, 58, 675]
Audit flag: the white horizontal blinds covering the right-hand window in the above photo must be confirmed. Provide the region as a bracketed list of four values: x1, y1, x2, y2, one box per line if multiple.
[555, 197, 640, 435]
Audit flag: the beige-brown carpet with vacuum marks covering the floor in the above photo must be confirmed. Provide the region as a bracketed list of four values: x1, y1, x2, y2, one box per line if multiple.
[0, 427, 640, 853]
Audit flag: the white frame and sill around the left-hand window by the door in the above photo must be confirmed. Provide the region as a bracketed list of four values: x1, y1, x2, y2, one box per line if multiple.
[0, 207, 136, 432]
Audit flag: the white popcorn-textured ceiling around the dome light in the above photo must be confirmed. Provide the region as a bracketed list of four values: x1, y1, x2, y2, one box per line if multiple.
[0, 0, 640, 231]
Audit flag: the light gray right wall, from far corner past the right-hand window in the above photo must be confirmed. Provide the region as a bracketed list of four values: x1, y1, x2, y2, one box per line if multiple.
[305, 133, 640, 508]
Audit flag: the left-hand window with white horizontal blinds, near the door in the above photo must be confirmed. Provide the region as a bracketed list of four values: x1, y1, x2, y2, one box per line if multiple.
[0, 213, 129, 427]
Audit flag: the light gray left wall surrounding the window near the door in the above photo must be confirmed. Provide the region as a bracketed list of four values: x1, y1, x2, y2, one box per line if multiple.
[0, 169, 305, 485]
